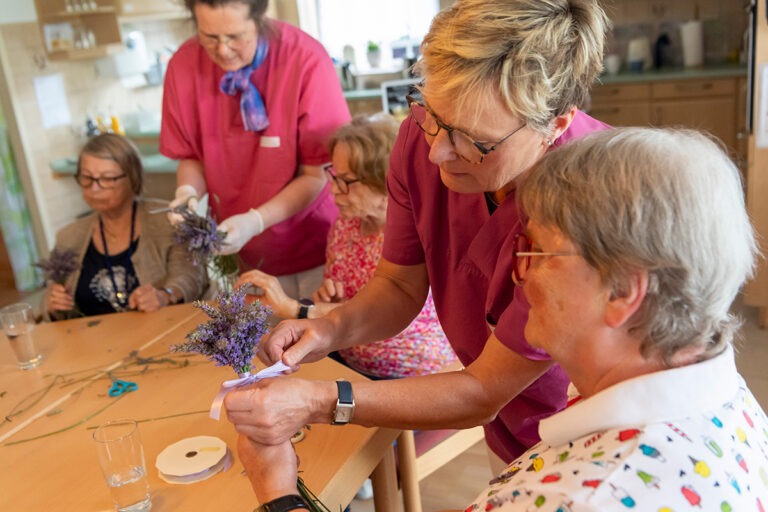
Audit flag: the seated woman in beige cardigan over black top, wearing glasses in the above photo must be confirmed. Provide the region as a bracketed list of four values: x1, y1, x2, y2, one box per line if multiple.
[45, 133, 206, 319]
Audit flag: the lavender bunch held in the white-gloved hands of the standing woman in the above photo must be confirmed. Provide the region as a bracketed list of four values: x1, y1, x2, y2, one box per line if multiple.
[173, 196, 239, 292]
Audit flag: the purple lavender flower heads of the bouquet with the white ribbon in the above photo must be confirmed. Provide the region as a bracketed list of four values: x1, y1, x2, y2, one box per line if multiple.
[171, 287, 272, 375]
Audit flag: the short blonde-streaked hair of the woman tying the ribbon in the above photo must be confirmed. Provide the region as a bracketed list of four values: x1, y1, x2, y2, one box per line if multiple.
[416, 0, 610, 132]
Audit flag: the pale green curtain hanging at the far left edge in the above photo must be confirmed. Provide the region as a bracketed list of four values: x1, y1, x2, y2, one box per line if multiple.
[0, 104, 43, 291]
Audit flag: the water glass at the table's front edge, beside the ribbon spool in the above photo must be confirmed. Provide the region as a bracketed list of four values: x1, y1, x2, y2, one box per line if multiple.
[93, 419, 152, 512]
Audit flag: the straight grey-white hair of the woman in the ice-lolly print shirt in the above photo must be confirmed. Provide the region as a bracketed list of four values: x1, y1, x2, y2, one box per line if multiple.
[518, 128, 758, 364]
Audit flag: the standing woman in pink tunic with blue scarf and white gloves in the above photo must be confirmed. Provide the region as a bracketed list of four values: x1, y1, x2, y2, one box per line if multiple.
[160, 0, 349, 296]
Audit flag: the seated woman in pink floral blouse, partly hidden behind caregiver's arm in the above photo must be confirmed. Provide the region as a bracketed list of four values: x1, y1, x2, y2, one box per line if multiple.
[235, 114, 456, 378]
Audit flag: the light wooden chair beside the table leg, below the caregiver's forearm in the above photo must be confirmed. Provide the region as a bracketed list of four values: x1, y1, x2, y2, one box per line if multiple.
[396, 362, 484, 512]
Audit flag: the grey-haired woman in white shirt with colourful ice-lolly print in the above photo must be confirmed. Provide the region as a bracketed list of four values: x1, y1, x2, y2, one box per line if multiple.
[239, 128, 768, 512]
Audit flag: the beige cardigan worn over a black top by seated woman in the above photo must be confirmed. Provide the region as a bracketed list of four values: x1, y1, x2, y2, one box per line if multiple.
[43, 200, 208, 317]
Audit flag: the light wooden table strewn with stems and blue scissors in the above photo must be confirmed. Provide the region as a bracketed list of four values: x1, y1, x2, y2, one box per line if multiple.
[0, 305, 400, 512]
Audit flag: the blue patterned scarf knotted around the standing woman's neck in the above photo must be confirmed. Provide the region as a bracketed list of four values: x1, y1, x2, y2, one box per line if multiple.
[220, 38, 269, 132]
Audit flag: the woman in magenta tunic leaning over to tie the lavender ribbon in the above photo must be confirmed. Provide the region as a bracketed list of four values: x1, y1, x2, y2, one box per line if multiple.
[226, 0, 609, 480]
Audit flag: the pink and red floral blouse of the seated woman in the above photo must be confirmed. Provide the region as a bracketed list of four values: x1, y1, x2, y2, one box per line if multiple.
[325, 217, 456, 378]
